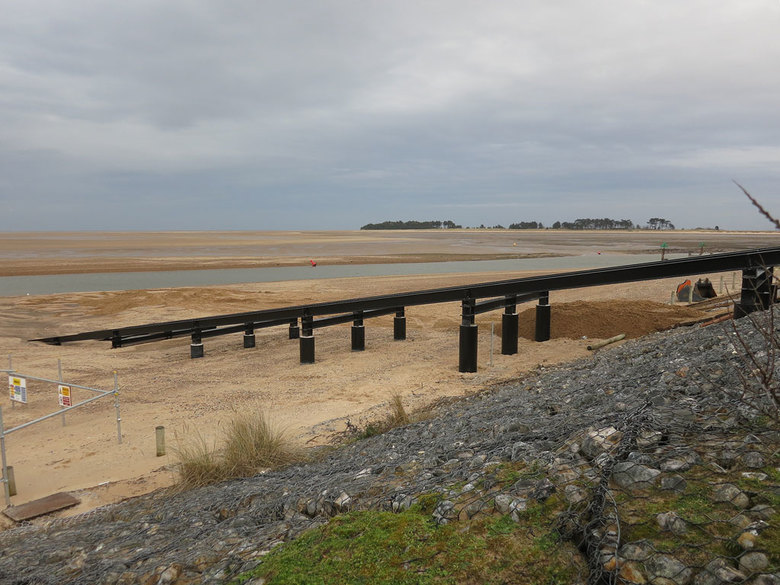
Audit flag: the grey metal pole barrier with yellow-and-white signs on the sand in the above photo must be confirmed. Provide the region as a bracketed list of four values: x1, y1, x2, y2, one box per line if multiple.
[0, 356, 122, 506]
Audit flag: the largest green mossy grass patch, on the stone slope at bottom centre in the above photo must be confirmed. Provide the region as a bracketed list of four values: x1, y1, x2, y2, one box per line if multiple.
[233, 505, 587, 585]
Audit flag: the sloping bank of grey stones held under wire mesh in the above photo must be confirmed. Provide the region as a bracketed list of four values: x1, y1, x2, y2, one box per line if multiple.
[0, 308, 780, 585]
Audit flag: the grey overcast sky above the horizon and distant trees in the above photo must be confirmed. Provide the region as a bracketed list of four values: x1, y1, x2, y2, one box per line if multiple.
[0, 0, 780, 231]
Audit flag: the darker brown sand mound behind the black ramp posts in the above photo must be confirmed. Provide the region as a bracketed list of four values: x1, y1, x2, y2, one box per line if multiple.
[519, 300, 706, 339]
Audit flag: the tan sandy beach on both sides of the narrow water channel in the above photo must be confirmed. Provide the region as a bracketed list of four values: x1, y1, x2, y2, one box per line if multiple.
[0, 231, 778, 515]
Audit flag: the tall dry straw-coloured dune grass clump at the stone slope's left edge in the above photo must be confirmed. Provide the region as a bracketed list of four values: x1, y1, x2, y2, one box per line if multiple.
[173, 410, 304, 489]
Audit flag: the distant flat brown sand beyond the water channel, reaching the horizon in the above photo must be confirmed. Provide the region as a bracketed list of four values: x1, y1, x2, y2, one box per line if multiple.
[0, 230, 780, 276]
